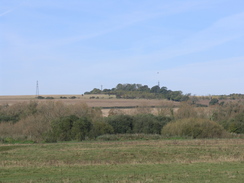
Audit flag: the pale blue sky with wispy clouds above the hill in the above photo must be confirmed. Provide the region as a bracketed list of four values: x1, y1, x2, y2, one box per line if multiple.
[0, 0, 244, 95]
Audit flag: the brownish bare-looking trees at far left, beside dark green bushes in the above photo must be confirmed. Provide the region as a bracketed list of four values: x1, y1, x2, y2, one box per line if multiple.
[0, 101, 102, 142]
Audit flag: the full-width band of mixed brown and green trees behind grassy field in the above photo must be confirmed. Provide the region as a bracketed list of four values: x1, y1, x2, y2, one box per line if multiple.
[0, 101, 244, 142]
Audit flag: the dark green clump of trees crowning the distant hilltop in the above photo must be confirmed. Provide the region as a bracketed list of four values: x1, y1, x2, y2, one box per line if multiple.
[85, 84, 190, 101]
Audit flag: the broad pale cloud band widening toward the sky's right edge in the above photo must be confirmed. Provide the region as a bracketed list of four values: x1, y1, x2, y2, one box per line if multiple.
[132, 12, 244, 62]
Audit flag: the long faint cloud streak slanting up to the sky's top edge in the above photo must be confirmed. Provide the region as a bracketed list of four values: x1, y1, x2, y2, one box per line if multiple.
[29, 0, 220, 47]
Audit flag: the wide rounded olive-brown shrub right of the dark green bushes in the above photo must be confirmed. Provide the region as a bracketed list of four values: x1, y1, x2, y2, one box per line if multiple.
[161, 118, 227, 138]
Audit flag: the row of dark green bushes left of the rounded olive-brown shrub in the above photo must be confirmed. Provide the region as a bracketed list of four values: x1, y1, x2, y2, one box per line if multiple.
[44, 114, 171, 142]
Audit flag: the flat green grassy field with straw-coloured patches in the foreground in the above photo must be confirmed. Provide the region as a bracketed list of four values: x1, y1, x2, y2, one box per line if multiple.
[0, 139, 244, 182]
